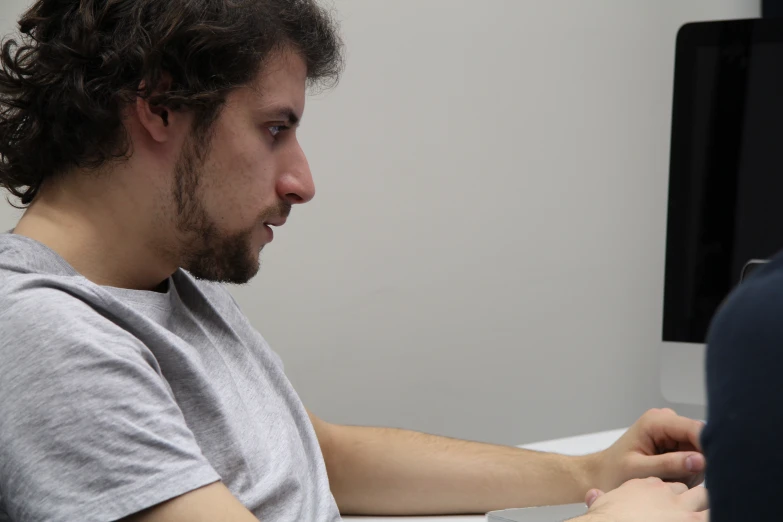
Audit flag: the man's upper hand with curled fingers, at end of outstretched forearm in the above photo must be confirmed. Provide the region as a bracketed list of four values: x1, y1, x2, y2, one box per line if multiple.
[588, 408, 705, 491]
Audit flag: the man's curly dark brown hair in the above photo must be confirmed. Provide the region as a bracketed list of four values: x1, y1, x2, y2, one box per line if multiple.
[0, 0, 343, 206]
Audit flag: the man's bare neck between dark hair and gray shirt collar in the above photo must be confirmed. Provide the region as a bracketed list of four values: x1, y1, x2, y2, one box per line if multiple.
[14, 173, 177, 290]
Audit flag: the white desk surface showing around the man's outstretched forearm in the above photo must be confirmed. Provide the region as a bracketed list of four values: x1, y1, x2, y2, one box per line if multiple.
[345, 429, 625, 522]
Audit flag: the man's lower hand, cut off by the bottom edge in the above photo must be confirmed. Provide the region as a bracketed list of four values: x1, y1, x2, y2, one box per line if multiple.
[575, 478, 709, 522]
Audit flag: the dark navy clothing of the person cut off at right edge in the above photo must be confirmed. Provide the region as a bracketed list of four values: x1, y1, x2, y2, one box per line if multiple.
[702, 250, 783, 522]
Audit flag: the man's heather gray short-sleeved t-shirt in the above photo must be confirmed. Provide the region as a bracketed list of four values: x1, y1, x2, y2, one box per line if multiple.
[0, 234, 340, 522]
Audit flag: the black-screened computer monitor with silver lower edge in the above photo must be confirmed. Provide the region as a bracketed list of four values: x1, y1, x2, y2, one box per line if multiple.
[661, 19, 783, 405]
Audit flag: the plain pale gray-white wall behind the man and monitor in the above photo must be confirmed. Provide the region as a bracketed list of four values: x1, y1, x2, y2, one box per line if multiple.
[0, 0, 759, 443]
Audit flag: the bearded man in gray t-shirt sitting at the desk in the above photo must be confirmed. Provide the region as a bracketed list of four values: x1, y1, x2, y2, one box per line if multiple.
[0, 0, 705, 522]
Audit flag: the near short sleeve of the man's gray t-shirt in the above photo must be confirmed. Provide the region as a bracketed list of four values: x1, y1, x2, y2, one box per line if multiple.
[0, 288, 220, 522]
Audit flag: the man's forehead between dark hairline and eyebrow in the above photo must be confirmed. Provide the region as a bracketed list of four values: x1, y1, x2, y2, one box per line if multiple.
[227, 50, 307, 112]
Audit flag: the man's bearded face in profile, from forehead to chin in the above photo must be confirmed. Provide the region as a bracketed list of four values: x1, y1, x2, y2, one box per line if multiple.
[170, 51, 315, 284]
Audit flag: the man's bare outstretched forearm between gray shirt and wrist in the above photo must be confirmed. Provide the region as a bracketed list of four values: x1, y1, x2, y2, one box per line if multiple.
[324, 426, 592, 515]
